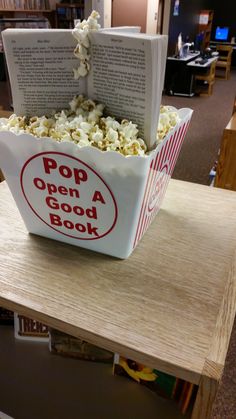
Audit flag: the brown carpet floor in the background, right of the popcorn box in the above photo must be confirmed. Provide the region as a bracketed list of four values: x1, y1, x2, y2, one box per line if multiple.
[162, 69, 236, 185]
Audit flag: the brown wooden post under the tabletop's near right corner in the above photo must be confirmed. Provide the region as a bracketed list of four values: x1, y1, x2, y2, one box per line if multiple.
[191, 376, 219, 419]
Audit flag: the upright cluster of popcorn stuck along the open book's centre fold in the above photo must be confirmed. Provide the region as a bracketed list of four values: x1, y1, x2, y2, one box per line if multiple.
[72, 10, 101, 80]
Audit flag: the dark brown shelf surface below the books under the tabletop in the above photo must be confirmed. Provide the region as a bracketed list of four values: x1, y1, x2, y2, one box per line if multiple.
[0, 326, 190, 419]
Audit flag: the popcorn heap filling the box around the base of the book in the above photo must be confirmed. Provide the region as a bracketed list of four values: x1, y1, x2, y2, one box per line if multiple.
[0, 95, 180, 157]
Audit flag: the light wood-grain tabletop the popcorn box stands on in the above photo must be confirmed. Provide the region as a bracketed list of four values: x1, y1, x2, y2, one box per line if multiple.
[0, 180, 236, 419]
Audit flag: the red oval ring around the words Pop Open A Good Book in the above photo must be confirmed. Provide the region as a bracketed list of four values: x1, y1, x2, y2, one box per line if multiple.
[20, 151, 118, 240]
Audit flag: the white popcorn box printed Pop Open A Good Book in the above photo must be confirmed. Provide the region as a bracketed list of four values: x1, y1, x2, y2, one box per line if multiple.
[0, 108, 192, 259]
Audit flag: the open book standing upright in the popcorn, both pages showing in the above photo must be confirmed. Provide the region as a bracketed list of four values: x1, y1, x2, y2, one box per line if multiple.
[2, 28, 167, 148]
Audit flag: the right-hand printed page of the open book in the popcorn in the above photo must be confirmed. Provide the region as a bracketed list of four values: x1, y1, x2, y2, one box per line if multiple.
[88, 31, 166, 145]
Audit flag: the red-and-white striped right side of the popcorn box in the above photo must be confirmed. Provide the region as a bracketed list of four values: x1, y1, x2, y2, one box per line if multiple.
[133, 121, 190, 247]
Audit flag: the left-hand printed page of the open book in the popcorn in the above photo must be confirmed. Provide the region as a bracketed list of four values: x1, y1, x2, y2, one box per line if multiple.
[2, 29, 86, 116]
